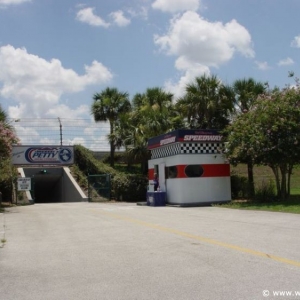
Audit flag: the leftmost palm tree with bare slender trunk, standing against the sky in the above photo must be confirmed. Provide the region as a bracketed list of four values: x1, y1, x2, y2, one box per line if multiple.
[91, 87, 131, 167]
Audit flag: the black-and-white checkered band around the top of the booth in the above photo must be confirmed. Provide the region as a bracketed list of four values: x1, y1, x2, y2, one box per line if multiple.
[151, 143, 224, 159]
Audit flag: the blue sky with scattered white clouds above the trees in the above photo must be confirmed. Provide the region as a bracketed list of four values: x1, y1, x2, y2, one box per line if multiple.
[0, 0, 300, 149]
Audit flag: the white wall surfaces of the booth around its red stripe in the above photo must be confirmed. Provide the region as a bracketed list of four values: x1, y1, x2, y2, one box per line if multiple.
[148, 154, 231, 205]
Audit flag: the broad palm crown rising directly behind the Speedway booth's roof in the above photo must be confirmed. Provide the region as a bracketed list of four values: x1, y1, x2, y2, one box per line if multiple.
[176, 75, 234, 129]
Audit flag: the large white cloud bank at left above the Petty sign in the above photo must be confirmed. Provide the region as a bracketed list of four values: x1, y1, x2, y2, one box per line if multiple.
[0, 45, 113, 118]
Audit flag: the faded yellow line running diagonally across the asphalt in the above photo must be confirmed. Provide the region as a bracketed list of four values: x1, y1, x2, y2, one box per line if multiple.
[90, 210, 300, 267]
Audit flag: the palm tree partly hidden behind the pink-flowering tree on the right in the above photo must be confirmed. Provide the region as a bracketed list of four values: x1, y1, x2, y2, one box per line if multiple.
[232, 78, 266, 197]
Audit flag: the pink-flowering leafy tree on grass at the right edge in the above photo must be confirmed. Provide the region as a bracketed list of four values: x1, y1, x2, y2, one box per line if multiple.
[226, 86, 300, 199]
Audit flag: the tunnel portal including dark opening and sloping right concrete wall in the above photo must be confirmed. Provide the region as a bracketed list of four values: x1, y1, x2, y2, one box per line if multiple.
[19, 167, 88, 203]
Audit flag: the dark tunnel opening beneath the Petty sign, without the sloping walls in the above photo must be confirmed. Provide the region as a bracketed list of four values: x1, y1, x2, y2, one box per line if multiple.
[24, 168, 65, 203]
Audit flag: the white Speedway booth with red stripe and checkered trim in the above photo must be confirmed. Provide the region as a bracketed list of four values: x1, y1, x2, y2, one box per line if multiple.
[148, 129, 231, 206]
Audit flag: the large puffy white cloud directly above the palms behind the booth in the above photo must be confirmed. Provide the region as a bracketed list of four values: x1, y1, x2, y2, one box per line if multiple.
[154, 11, 255, 94]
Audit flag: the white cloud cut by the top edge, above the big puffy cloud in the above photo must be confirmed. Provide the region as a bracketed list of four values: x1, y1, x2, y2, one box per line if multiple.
[152, 0, 200, 13]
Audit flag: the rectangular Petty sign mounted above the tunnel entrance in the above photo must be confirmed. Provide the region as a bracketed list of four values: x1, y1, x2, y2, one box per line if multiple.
[12, 146, 74, 165]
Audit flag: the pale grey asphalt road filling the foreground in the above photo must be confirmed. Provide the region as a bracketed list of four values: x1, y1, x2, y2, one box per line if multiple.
[0, 203, 300, 300]
